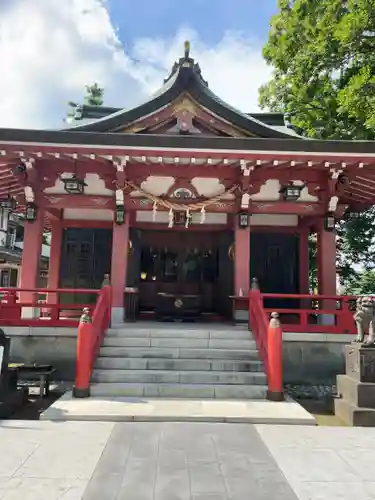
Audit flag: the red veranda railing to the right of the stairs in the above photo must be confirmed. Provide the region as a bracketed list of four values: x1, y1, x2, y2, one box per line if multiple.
[260, 293, 357, 334]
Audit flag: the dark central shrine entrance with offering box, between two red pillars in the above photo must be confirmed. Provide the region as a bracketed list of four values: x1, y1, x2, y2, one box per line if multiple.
[139, 230, 228, 316]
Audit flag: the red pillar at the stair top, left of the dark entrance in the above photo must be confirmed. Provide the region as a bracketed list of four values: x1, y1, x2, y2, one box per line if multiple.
[111, 212, 129, 324]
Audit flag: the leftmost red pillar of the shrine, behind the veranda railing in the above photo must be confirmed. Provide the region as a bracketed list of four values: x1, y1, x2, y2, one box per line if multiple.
[20, 208, 44, 310]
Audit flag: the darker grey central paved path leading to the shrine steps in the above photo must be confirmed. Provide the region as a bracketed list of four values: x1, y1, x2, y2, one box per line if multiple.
[83, 423, 297, 500]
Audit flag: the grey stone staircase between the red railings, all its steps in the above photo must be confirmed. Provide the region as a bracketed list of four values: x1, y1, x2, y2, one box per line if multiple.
[91, 324, 267, 400]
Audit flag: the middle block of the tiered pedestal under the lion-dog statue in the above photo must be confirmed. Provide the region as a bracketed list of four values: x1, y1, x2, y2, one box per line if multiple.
[337, 375, 375, 409]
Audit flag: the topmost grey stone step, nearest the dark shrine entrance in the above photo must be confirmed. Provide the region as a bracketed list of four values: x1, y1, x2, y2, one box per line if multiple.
[106, 327, 253, 340]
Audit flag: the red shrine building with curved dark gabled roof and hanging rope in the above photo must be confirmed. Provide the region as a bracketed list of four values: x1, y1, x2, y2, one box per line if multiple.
[0, 44, 375, 320]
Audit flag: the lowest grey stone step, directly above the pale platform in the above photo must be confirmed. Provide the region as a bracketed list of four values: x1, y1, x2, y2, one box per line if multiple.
[90, 383, 267, 400]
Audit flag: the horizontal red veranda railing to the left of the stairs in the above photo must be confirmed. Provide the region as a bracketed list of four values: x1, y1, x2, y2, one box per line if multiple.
[0, 288, 100, 327]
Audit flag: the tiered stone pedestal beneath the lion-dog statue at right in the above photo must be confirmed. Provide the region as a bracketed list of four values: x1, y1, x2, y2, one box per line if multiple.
[335, 343, 375, 427]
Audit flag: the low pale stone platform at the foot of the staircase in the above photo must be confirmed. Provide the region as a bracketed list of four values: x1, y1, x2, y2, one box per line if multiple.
[40, 392, 316, 425]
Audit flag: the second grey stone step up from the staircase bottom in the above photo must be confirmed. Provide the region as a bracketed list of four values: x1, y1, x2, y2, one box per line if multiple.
[92, 369, 266, 385]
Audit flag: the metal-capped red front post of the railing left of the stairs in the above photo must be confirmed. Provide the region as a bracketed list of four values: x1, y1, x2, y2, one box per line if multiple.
[73, 308, 93, 398]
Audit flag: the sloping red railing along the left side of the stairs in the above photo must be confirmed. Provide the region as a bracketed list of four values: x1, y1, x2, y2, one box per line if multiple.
[73, 286, 111, 398]
